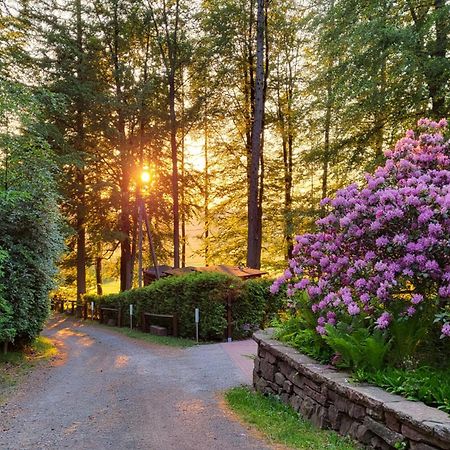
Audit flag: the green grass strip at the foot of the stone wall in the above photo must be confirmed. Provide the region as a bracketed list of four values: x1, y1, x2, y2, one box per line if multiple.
[225, 387, 359, 450]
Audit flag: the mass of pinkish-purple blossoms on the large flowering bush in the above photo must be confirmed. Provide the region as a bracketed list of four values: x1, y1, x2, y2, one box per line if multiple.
[271, 119, 450, 335]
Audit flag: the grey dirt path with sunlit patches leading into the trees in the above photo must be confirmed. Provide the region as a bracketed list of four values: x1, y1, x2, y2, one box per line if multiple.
[0, 319, 269, 450]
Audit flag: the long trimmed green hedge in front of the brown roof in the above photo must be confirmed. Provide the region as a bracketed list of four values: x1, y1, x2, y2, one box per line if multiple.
[84, 273, 283, 340]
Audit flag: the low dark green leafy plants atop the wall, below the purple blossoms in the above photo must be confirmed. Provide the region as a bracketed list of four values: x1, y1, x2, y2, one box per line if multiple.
[355, 366, 450, 413]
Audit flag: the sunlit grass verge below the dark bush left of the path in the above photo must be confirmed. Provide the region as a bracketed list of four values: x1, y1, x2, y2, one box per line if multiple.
[0, 336, 58, 404]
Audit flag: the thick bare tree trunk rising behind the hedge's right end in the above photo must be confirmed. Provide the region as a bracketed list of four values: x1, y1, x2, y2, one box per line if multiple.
[247, 0, 265, 269]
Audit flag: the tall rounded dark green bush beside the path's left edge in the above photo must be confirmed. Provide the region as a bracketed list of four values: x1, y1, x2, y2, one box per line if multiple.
[0, 84, 62, 345]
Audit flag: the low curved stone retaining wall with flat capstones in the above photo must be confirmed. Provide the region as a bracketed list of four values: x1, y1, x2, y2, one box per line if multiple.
[253, 330, 450, 450]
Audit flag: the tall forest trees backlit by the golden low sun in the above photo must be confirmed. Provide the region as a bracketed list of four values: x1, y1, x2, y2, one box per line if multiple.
[0, 0, 450, 307]
